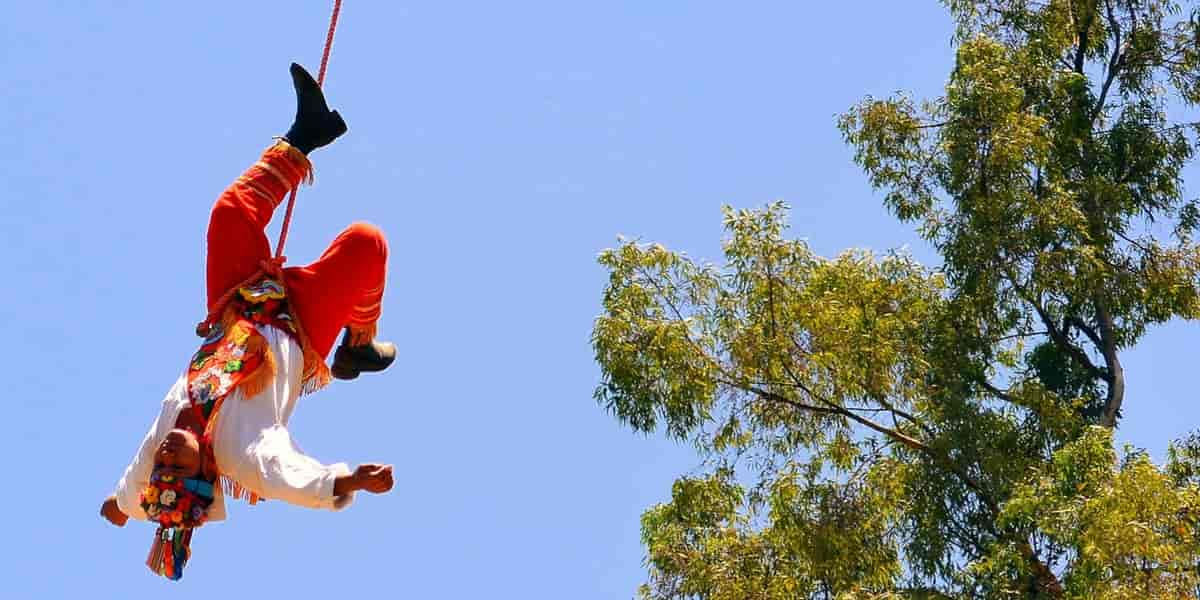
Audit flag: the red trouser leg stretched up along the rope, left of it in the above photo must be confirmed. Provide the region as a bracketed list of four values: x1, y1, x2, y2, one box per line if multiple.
[208, 142, 310, 310]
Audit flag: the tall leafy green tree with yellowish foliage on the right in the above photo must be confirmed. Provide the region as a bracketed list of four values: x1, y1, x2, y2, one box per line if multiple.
[593, 0, 1200, 600]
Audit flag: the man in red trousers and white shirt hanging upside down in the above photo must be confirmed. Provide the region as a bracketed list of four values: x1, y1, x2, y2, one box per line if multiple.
[101, 64, 396, 580]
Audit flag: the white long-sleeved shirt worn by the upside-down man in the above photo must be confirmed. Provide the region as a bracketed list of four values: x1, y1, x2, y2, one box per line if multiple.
[115, 325, 354, 521]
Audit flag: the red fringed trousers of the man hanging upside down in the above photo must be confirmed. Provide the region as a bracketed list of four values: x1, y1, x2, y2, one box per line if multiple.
[208, 142, 388, 360]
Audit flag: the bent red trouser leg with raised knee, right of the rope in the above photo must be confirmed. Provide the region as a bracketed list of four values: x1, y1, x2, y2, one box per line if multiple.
[283, 223, 388, 358]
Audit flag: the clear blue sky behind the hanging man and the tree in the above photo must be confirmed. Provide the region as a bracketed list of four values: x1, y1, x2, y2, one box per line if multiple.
[0, 0, 1200, 599]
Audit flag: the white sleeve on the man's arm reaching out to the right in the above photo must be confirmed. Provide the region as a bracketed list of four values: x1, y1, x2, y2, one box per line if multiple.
[230, 425, 354, 510]
